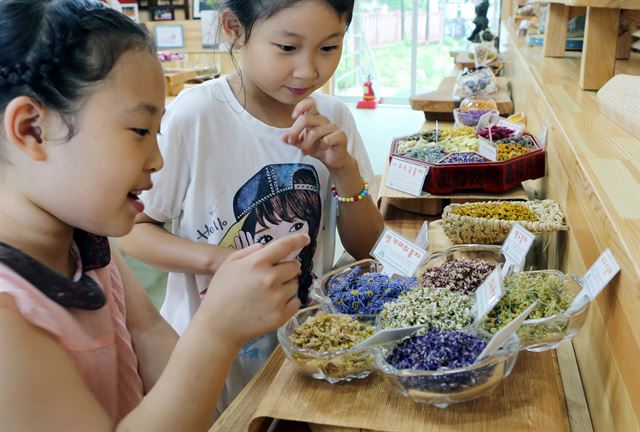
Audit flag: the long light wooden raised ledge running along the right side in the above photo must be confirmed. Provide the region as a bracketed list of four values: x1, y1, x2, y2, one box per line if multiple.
[501, 27, 640, 432]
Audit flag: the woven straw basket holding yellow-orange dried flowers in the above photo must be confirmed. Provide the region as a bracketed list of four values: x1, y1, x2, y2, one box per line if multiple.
[442, 200, 567, 244]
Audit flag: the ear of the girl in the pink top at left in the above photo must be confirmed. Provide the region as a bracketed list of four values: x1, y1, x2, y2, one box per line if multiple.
[3, 96, 47, 161]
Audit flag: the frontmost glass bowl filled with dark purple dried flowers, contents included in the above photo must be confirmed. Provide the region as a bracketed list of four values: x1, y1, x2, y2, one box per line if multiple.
[374, 327, 520, 408]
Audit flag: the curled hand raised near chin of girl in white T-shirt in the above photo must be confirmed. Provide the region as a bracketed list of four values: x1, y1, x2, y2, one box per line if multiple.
[282, 98, 353, 170]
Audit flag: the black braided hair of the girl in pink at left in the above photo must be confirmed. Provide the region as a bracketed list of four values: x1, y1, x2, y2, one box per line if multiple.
[0, 0, 155, 142]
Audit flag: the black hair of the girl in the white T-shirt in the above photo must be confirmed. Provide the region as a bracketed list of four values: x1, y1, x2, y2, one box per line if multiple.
[222, 0, 355, 42]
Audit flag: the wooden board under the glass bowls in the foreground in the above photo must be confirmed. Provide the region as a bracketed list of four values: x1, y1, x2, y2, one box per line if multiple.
[210, 200, 588, 432]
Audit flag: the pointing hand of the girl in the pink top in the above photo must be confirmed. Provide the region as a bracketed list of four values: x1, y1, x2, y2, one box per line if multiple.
[196, 234, 309, 347]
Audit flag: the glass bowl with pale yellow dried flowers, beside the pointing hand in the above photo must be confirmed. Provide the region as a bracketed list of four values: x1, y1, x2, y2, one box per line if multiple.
[277, 304, 375, 384]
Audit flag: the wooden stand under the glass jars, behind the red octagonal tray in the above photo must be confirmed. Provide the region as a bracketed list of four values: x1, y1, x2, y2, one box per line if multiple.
[409, 76, 513, 121]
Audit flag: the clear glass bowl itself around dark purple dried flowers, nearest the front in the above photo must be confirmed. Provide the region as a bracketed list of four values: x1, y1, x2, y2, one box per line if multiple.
[374, 330, 520, 408]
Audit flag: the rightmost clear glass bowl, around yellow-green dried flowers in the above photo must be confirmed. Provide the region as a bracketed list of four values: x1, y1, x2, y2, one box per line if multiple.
[484, 270, 591, 352]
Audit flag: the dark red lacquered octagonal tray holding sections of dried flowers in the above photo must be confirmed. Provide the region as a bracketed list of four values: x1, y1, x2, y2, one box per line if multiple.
[389, 137, 545, 194]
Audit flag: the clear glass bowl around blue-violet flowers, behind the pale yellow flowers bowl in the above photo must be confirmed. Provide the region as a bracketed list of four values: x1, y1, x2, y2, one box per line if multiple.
[309, 258, 420, 315]
